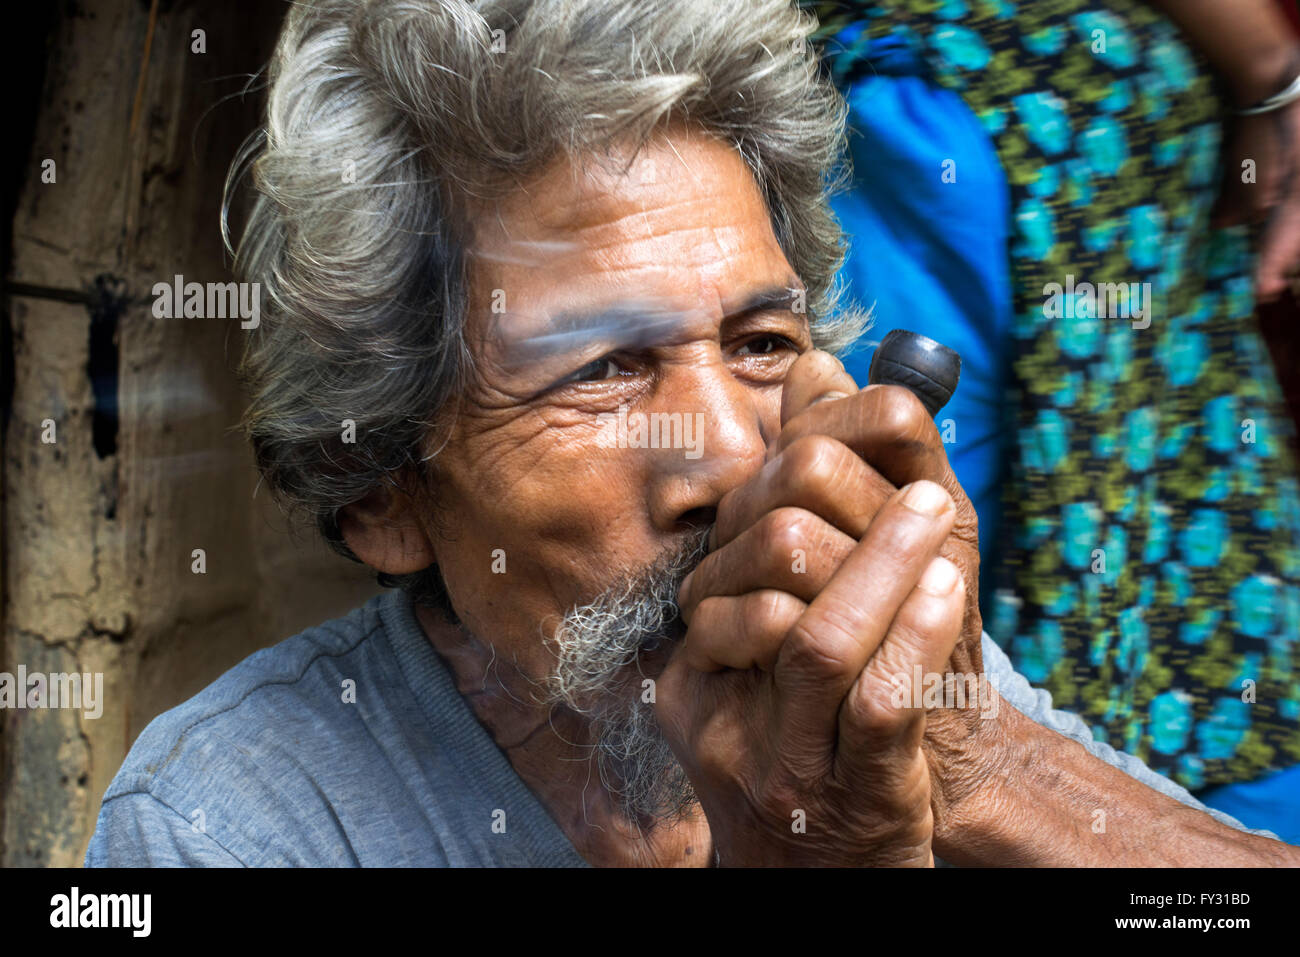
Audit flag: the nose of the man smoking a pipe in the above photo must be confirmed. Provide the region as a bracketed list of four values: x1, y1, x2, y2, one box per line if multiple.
[647, 363, 764, 532]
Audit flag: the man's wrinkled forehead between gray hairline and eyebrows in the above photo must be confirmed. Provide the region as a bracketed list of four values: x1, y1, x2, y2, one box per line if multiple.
[469, 129, 797, 360]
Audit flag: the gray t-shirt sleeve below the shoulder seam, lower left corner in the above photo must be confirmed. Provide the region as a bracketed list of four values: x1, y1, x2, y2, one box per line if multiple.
[86, 791, 244, 867]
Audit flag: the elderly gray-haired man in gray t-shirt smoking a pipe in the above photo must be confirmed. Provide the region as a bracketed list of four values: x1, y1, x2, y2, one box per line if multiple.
[87, 0, 1300, 866]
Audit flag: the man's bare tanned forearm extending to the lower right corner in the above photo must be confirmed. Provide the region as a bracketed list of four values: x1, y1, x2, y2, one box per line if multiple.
[935, 705, 1300, 867]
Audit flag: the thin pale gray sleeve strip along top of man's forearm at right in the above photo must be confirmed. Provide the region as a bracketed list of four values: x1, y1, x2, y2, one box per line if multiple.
[983, 635, 1278, 840]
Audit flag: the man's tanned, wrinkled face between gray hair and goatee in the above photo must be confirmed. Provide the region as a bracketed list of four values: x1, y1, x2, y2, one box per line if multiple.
[430, 130, 811, 696]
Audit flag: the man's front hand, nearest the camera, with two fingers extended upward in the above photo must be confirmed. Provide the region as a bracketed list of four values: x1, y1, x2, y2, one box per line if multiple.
[655, 473, 966, 866]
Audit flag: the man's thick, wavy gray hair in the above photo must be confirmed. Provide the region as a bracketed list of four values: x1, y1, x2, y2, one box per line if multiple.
[222, 0, 863, 598]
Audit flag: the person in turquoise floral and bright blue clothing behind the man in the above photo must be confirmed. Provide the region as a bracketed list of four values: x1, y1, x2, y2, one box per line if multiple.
[805, 0, 1300, 840]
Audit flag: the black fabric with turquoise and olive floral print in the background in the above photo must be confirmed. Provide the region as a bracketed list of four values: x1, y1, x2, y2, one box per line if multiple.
[806, 0, 1300, 789]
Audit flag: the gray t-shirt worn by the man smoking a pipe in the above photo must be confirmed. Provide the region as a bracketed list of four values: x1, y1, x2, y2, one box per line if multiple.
[86, 592, 1271, 867]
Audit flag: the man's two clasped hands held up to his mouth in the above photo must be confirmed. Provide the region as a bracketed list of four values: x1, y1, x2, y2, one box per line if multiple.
[659, 352, 980, 863]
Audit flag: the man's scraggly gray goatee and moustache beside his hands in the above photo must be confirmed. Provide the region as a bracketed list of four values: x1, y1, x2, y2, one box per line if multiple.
[549, 528, 710, 827]
